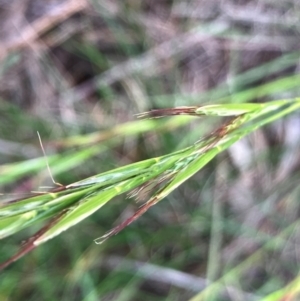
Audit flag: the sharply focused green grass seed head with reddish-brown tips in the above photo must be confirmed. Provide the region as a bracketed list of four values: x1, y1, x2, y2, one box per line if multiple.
[0, 98, 300, 269]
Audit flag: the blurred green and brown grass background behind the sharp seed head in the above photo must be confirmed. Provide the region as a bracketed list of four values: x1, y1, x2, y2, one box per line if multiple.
[0, 0, 300, 301]
